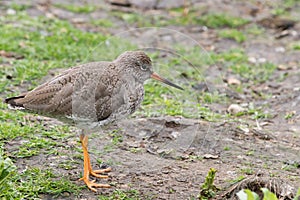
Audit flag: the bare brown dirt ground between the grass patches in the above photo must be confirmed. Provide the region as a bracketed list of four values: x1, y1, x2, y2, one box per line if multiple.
[0, 0, 300, 199]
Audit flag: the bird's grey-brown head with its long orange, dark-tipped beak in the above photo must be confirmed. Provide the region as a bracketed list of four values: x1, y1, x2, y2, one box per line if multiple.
[116, 51, 183, 90]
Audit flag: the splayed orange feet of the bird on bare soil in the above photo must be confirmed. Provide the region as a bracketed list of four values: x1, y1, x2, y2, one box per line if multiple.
[79, 168, 111, 192]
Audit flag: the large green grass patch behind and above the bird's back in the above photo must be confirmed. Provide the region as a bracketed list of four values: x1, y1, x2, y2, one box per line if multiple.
[0, 13, 106, 92]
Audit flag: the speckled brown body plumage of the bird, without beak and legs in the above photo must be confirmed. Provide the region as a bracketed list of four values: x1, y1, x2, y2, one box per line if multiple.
[6, 52, 152, 124]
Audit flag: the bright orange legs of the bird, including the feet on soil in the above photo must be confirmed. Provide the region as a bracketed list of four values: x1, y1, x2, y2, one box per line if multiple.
[79, 134, 111, 192]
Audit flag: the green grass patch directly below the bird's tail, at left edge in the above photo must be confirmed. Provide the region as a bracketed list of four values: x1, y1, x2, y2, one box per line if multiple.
[0, 103, 72, 158]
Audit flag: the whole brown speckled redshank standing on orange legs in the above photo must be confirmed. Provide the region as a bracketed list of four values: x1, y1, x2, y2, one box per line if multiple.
[5, 51, 183, 191]
